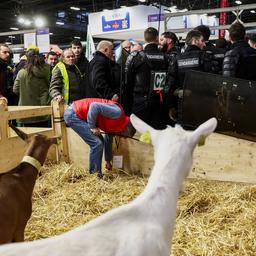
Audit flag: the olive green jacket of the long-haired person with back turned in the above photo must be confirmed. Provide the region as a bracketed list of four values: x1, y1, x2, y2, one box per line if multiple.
[13, 64, 51, 123]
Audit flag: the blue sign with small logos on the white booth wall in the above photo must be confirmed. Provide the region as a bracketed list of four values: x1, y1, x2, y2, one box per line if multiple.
[102, 12, 130, 32]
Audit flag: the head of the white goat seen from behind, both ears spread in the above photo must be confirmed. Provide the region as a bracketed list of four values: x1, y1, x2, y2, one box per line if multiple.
[130, 114, 217, 181]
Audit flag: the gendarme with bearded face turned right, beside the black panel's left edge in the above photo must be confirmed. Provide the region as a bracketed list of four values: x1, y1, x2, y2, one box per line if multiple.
[169, 30, 219, 123]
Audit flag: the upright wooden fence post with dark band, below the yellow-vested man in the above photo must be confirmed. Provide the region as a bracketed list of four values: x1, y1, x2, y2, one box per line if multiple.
[52, 100, 69, 162]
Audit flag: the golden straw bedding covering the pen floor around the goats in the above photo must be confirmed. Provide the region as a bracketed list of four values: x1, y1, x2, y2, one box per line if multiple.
[25, 163, 256, 256]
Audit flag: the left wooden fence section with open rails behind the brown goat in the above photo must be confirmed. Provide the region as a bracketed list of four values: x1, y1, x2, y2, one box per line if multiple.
[0, 102, 69, 173]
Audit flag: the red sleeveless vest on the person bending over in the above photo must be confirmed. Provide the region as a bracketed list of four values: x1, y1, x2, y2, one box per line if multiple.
[73, 98, 129, 133]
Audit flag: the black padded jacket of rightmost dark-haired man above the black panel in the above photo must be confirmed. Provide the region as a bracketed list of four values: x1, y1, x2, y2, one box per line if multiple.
[223, 41, 256, 80]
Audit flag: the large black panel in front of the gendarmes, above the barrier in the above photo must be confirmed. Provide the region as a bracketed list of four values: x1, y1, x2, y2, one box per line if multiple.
[181, 71, 256, 141]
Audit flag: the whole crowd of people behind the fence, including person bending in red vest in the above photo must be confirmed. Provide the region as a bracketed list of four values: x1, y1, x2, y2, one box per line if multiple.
[0, 23, 256, 178]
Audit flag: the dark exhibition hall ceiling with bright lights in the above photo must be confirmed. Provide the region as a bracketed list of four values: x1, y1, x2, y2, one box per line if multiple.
[0, 0, 256, 44]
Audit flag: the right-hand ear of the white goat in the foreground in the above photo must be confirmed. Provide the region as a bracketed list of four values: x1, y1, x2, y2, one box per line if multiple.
[190, 118, 217, 146]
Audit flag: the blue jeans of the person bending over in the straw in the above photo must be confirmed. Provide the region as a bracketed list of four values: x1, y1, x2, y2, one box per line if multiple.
[64, 106, 116, 174]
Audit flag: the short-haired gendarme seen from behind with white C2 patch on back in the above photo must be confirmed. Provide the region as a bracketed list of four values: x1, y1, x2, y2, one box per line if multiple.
[124, 27, 169, 129]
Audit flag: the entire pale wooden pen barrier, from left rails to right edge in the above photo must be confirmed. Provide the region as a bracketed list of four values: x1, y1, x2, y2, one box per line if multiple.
[0, 102, 256, 183]
